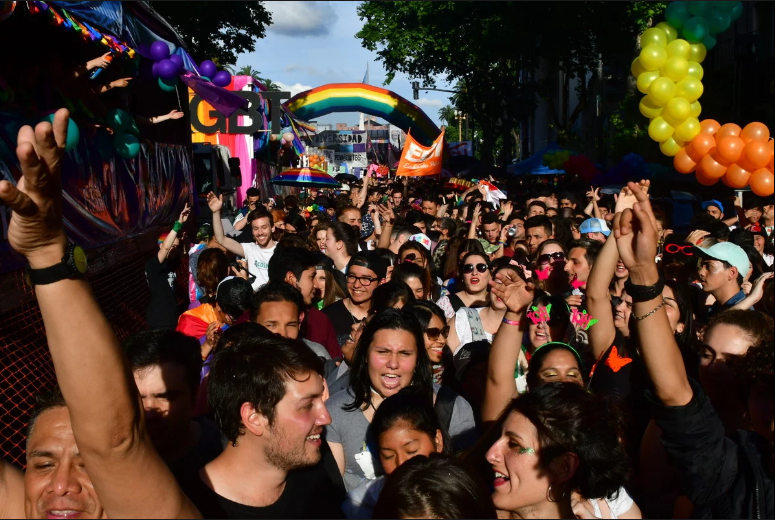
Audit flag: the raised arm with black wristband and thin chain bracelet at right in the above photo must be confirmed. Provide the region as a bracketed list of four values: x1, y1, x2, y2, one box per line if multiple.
[614, 182, 693, 406]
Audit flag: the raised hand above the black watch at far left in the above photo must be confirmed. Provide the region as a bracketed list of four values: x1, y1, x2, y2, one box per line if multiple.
[0, 108, 70, 268]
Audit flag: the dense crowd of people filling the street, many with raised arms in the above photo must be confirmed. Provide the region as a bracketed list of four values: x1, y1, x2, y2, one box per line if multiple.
[0, 110, 775, 518]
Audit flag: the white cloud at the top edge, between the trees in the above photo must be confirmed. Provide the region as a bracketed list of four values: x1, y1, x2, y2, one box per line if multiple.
[264, 2, 339, 37]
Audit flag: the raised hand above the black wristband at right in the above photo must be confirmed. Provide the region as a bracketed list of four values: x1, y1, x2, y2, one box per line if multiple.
[614, 182, 659, 285]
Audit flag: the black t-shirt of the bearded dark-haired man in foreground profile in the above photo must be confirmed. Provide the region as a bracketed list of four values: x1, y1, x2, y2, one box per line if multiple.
[181, 458, 345, 518]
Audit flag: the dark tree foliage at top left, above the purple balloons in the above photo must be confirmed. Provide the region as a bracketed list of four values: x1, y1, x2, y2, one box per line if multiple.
[149, 1, 272, 64]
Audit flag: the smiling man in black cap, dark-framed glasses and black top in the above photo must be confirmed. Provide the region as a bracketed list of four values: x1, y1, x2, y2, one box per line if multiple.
[323, 251, 387, 346]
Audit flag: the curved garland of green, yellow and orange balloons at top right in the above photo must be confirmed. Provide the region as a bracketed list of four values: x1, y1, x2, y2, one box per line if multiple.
[631, 1, 775, 196]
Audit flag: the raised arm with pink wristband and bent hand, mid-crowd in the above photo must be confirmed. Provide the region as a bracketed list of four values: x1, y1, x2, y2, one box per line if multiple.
[482, 271, 534, 423]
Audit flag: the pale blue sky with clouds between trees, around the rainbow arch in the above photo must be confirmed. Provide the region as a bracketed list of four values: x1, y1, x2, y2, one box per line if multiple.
[237, 1, 451, 125]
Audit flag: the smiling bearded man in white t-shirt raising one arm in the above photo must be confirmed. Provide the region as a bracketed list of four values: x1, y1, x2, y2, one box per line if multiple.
[207, 192, 277, 291]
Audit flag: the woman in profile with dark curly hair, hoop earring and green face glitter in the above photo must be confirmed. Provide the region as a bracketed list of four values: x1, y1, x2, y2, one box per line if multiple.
[486, 383, 629, 518]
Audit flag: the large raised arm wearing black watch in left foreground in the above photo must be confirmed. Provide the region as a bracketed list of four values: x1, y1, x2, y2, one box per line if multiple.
[0, 109, 198, 518]
